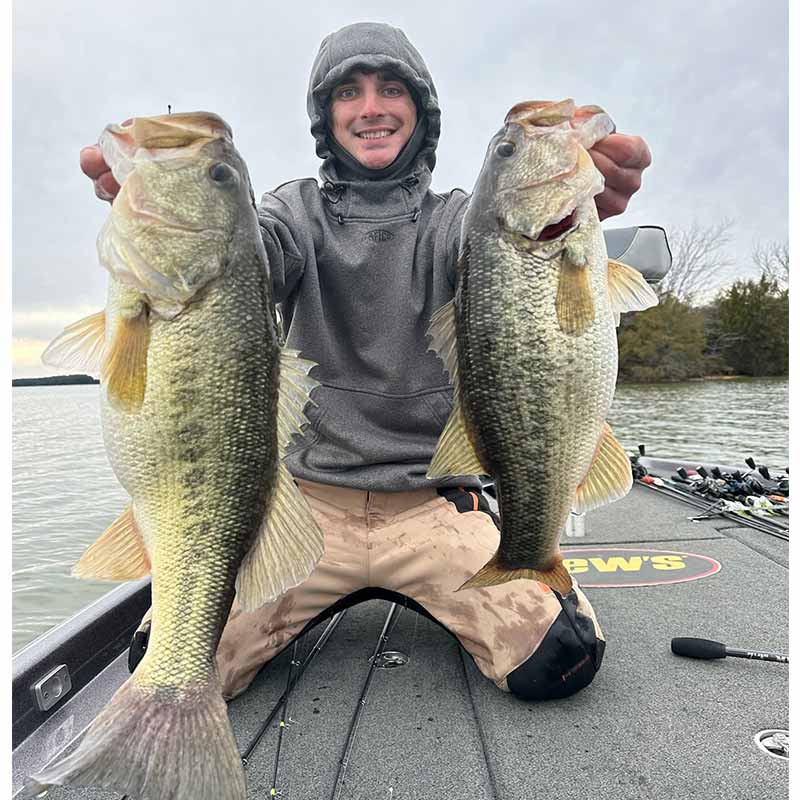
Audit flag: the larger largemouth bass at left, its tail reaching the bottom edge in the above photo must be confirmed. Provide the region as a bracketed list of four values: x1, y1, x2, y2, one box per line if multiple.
[30, 113, 323, 800]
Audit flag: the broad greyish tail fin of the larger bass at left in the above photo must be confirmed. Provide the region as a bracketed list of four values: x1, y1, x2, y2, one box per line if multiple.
[23, 672, 246, 800]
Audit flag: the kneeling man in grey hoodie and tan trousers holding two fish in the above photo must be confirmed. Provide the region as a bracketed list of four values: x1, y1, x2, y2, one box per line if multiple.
[81, 23, 650, 699]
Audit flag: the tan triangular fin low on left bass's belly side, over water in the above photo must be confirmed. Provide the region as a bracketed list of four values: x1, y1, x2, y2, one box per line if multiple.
[72, 506, 150, 581]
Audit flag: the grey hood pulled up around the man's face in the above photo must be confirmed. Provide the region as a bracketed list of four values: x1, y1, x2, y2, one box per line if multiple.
[307, 22, 441, 180]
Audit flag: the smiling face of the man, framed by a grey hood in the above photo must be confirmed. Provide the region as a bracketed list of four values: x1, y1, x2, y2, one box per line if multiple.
[330, 71, 417, 169]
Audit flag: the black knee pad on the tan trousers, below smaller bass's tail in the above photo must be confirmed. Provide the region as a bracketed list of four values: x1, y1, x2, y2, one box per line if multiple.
[506, 591, 605, 700]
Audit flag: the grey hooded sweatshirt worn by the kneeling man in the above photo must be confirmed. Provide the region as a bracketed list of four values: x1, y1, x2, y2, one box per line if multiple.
[259, 23, 668, 491]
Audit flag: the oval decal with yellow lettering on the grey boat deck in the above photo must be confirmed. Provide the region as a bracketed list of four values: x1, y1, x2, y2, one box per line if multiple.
[561, 547, 722, 586]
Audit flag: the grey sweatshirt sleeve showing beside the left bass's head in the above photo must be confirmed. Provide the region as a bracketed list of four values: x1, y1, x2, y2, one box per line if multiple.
[258, 187, 308, 303]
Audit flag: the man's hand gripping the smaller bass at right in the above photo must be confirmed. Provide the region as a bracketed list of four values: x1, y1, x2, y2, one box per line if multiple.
[589, 133, 653, 220]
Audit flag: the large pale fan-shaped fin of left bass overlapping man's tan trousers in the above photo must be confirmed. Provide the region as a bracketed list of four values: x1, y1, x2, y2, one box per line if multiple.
[236, 462, 325, 611]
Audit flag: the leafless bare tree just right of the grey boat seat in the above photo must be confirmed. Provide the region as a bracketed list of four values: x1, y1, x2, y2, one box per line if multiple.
[658, 219, 734, 305]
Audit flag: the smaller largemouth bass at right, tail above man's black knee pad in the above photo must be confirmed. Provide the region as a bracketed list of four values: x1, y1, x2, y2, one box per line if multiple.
[428, 100, 658, 594]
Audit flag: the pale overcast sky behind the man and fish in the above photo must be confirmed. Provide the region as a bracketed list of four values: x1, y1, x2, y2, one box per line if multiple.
[12, 0, 788, 376]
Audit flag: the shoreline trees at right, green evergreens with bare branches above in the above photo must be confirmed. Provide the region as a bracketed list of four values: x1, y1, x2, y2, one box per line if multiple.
[618, 221, 789, 383]
